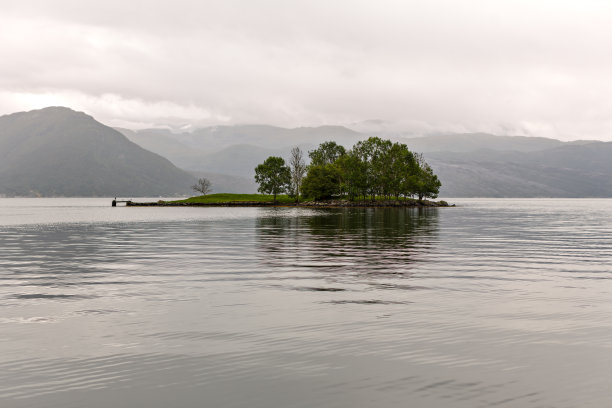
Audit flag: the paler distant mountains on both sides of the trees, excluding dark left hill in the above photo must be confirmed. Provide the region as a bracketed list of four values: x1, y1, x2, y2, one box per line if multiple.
[119, 125, 612, 197]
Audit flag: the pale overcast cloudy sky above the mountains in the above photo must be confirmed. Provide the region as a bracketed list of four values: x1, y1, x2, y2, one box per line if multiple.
[0, 0, 612, 140]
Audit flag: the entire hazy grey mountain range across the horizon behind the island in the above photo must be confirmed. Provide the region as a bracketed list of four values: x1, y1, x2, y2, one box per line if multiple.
[0, 107, 612, 197]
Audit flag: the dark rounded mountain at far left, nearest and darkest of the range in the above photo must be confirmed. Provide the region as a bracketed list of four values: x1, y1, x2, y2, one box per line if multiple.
[0, 107, 194, 196]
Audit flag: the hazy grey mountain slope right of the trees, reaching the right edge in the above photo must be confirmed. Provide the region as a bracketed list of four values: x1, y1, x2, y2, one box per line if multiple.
[426, 142, 612, 197]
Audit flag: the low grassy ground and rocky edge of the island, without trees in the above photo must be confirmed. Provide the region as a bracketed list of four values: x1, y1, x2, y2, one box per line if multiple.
[126, 194, 454, 208]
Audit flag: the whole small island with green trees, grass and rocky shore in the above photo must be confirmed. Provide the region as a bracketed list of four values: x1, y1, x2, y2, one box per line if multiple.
[126, 137, 450, 208]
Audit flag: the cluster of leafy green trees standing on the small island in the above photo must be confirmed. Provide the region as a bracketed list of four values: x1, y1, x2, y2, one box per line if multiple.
[255, 137, 441, 200]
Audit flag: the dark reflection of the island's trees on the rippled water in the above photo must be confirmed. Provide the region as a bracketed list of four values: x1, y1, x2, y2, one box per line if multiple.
[256, 208, 439, 284]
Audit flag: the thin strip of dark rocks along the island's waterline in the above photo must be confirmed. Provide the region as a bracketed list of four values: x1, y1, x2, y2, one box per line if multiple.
[126, 200, 455, 208]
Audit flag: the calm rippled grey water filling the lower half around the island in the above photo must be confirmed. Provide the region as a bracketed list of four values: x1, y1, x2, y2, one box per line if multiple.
[0, 199, 612, 408]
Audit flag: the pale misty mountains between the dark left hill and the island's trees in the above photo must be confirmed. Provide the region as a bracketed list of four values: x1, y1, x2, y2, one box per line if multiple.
[117, 125, 366, 193]
